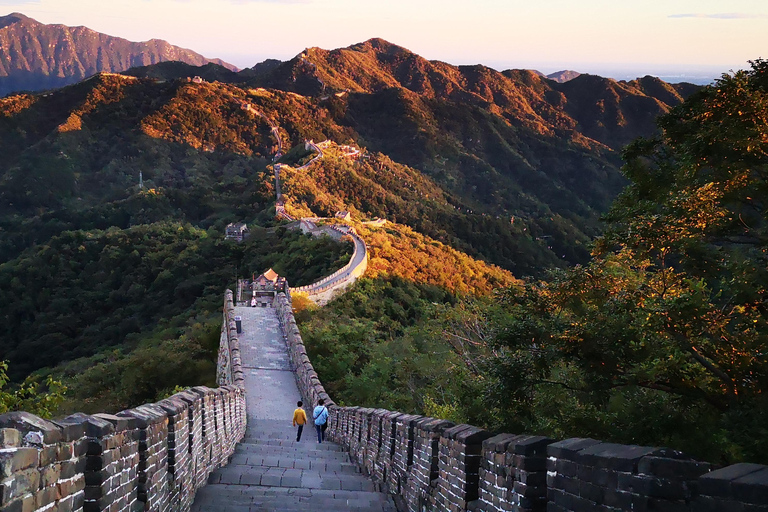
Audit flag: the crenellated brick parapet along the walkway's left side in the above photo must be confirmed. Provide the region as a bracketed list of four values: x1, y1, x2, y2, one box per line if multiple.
[0, 292, 246, 512]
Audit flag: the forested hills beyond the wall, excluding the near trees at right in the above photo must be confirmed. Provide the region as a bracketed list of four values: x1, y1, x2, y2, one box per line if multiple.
[0, 43, 704, 426]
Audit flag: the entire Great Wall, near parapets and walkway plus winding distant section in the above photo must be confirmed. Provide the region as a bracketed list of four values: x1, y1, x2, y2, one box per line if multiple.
[0, 123, 768, 512]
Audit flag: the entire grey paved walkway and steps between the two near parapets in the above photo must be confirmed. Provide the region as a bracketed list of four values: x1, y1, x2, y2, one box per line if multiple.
[191, 307, 396, 512]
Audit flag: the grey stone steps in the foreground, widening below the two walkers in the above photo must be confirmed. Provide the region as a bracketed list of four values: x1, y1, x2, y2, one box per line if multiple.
[192, 420, 396, 512]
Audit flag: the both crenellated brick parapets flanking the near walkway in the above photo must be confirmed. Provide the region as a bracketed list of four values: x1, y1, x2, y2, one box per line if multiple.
[0, 292, 768, 512]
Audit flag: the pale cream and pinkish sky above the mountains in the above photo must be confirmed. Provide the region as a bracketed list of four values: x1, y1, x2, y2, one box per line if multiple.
[0, 0, 768, 78]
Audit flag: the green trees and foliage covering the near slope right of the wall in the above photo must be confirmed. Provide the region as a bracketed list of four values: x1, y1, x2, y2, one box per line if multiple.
[299, 60, 768, 463]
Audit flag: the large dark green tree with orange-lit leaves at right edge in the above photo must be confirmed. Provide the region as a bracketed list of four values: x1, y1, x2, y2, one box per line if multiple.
[492, 60, 768, 462]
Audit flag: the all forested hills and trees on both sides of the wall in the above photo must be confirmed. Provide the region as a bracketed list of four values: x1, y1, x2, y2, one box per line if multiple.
[0, 41, 768, 468]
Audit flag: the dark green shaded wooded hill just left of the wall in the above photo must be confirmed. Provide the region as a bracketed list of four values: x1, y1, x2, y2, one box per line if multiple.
[0, 216, 352, 411]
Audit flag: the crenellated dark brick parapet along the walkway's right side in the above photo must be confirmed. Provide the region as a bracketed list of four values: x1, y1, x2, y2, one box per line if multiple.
[275, 294, 768, 512]
